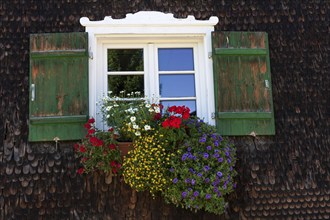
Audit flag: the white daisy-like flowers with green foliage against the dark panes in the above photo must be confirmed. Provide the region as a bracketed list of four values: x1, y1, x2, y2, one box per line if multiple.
[101, 91, 162, 140]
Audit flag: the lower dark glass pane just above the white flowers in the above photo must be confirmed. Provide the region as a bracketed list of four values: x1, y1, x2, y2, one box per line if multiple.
[108, 75, 144, 96]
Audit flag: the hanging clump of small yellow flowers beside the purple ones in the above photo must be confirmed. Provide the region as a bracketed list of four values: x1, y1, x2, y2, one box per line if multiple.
[123, 131, 170, 196]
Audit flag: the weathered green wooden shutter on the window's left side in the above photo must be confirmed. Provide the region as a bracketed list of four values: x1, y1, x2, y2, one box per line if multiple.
[29, 32, 88, 141]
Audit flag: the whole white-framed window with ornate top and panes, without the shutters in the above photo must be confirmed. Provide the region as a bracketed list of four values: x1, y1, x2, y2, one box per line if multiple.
[81, 12, 218, 128]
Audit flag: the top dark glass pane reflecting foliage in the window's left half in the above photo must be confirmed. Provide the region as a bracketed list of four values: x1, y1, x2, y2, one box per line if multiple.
[108, 49, 143, 71]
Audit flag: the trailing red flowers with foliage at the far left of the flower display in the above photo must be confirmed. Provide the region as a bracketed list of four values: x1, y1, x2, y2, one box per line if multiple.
[74, 118, 121, 174]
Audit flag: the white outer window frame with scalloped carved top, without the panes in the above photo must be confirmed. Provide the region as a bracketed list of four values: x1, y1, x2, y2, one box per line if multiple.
[80, 11, 218, 128]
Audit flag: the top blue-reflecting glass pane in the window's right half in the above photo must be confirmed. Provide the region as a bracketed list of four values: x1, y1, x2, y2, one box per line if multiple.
[158, 48, 194, 71]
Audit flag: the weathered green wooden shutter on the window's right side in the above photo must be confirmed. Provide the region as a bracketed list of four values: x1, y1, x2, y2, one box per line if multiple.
[212, 32, 275, 135]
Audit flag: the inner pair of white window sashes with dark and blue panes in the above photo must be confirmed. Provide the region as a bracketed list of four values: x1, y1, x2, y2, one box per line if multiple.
[107, 42, 198, 113]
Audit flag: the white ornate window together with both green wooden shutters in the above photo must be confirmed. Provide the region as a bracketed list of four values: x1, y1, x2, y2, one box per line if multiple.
[29, 12, 275, 141]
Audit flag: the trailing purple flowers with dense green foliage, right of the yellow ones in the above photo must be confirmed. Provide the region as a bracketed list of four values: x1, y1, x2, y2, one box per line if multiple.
[163, 119, 236, 214]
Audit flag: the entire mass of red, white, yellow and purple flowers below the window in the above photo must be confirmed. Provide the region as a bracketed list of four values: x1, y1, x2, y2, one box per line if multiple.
[75, 92, 236, 214]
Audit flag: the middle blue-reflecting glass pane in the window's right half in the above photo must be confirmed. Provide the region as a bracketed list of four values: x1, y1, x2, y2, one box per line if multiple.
[159, 74, 195, 97]
